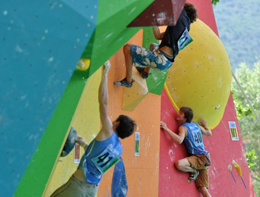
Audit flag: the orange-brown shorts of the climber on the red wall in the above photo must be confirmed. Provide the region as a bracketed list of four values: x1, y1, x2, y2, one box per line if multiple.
[186, 155, 209, 189]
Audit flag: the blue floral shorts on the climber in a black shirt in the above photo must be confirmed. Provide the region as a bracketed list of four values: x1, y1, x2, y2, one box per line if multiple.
[131, 45, 172, 70]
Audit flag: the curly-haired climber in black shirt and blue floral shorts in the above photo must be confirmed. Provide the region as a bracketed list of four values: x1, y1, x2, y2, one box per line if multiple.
[114, 2, 198, 88]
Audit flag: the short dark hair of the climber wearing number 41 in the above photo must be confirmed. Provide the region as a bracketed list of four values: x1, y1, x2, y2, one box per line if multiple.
[116, 115, 136, 139]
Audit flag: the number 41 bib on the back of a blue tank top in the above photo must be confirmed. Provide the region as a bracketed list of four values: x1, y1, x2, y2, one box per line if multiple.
[91, 144, 120, 174]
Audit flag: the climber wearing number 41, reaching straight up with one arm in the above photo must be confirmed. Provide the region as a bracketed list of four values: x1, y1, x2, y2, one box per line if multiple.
[51, 61, 136, 197]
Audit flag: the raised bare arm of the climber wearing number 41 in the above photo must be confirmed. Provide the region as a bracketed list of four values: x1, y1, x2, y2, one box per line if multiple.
[96, 61, 113, 141]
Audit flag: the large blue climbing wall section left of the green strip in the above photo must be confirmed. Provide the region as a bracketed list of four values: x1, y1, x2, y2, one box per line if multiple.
[0, 0, 98, 196]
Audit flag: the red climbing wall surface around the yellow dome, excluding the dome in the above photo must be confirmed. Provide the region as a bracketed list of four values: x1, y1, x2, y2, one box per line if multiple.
[159, 0, 255, 197]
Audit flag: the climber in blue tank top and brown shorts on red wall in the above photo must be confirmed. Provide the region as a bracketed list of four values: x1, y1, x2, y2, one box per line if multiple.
[161, 107, 212, 197]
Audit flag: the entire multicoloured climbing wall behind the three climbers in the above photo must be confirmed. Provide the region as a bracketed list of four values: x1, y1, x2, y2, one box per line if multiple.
[0, 0, 254, 197]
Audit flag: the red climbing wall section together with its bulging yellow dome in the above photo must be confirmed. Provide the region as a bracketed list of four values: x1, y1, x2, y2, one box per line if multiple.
[159, 0, 255, 197]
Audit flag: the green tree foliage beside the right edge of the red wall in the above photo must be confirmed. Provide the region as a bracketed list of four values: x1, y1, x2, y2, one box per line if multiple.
[232, 60, 260, 196]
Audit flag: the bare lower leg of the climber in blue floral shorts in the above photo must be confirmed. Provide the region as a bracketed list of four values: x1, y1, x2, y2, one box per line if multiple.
[123, 44, 133, 83]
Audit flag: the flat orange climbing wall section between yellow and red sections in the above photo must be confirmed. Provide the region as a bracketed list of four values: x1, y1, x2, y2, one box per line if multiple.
[98, 37, 161, 197]
